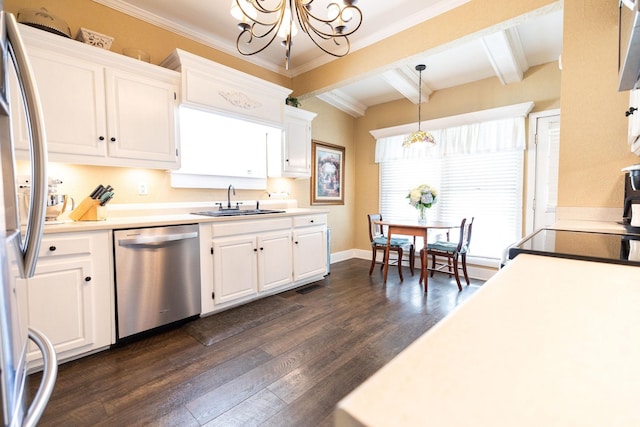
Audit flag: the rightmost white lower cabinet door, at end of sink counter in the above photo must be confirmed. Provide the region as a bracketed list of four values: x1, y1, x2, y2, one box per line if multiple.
[293, 227, 327, 281]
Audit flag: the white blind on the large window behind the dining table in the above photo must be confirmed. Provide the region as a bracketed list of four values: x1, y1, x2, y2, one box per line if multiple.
[379, 150, 524, 259]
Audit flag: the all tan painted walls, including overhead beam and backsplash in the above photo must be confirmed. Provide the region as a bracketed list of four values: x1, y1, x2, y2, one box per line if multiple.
[4, 0, 638, 258]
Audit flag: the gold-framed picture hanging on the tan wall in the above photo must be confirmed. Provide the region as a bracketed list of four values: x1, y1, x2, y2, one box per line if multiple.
[311, 141, 344, 205]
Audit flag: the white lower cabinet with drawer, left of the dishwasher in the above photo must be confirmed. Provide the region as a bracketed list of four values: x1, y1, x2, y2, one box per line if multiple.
[18, 231, 113, 367]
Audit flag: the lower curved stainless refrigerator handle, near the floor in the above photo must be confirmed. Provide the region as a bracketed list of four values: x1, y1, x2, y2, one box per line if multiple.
[23, 328, 58, 427]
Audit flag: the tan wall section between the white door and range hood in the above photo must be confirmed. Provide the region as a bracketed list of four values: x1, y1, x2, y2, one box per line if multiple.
[558, 0, 639, 208]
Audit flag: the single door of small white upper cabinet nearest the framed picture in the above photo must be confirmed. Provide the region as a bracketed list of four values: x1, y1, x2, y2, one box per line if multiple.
[283, 117, 311, 177]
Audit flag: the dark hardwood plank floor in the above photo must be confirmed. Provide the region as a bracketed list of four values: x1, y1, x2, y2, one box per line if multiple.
[30, 259, 482, 427]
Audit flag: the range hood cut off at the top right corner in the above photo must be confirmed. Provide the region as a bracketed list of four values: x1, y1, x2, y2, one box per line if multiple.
[618, 0, 640, 91]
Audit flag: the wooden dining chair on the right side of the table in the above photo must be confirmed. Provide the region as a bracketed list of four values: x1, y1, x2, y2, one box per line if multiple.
[420, 217, 474, 291]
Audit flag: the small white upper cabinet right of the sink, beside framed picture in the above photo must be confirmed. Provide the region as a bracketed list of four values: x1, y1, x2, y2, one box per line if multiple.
[268, 105, 317, 178]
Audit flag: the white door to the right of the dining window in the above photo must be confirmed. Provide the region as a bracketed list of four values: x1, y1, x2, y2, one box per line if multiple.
[527, 110, 560, 233]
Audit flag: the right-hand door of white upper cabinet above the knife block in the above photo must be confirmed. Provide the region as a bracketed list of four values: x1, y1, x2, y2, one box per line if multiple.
[106, 69, 178, 163]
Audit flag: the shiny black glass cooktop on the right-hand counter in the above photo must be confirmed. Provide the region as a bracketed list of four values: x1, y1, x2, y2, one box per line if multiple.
[509, 228, 640, 266]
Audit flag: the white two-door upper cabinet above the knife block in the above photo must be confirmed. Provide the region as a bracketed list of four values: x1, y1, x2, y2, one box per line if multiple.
[11, 26, 180, 169]
